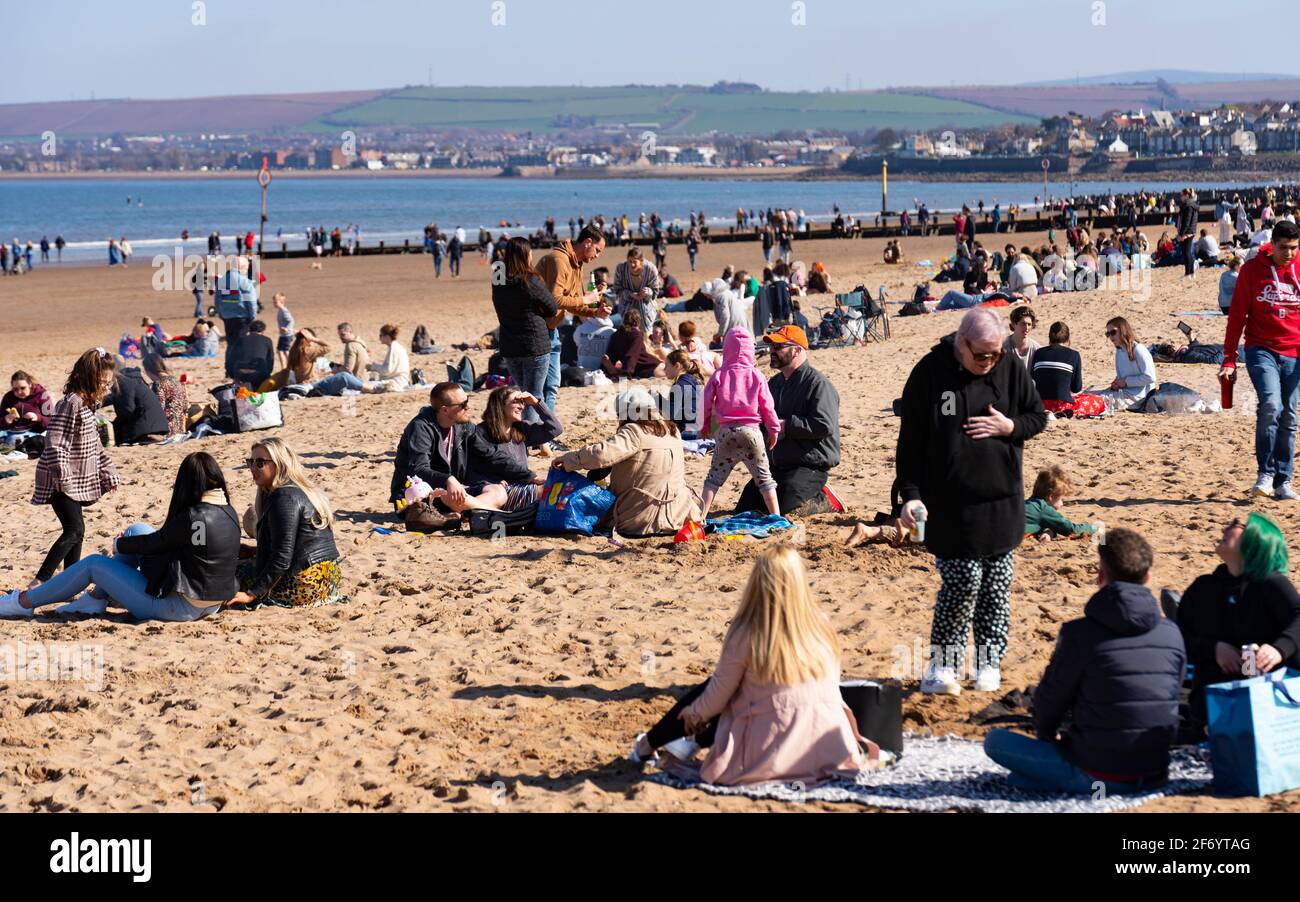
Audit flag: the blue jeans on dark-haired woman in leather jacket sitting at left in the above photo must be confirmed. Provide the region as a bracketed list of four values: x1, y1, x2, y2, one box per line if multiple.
[27, 524, 220, 623]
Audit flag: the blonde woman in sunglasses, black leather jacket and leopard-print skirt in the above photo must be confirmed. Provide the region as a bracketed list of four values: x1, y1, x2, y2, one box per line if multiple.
[229, 438, 343, 607]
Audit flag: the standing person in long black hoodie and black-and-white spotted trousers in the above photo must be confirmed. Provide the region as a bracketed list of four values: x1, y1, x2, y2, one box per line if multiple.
[899, 309, 1047, 695]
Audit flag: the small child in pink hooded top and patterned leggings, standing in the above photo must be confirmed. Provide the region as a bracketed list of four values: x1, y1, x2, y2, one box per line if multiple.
[699, 329, 781, 520]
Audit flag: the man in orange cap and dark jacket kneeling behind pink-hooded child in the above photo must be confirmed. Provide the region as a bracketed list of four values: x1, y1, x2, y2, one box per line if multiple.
[736, 326, 840, 516]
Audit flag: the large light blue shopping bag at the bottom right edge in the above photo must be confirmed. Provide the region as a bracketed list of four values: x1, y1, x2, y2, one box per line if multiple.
[1205, 669, 1300, 795]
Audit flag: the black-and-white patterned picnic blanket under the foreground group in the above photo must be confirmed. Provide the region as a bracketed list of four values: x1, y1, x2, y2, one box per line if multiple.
[649, 734, 1212, 814]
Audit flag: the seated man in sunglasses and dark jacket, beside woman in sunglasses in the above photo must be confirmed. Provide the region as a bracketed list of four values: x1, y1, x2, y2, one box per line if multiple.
[389, 382, 507, 532]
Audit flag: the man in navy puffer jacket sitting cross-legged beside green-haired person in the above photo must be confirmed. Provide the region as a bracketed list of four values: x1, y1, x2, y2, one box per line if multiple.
[984, 529, 1187, 793]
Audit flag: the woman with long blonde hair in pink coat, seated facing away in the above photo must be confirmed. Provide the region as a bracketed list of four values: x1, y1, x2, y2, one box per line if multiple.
[631, 545, 865, 785]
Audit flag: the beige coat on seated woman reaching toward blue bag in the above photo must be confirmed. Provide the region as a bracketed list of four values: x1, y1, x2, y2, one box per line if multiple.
[560, 422, 699, 537]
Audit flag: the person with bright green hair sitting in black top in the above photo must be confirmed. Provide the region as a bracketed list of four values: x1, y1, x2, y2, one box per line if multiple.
[1178, 513, 1300, 728]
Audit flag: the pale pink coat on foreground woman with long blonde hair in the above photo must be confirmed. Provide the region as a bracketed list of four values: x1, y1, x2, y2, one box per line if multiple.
[686, 632, 866, 786]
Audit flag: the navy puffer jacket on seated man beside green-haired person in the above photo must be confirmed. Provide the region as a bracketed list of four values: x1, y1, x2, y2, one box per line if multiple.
[1034, 582, 1187, 777]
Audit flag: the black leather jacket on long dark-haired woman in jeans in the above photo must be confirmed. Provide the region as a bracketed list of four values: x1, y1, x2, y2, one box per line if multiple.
[117, 503, 241, 602]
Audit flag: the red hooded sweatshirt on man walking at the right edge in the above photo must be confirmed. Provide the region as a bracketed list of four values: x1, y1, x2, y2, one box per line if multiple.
[1223, 244, 1300, 367]
